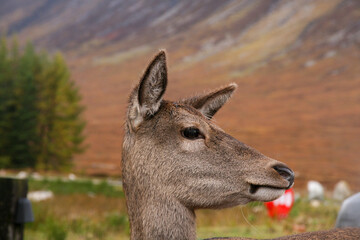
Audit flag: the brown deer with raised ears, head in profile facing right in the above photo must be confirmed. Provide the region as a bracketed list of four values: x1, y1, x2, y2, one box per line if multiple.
[122, 50, 360, 240]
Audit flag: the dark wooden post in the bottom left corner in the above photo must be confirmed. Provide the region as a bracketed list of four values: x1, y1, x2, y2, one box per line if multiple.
[0, 178, 28, 240]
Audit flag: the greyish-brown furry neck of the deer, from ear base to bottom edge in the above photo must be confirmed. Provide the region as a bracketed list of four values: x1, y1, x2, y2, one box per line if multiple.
[122, 128, 196, 240]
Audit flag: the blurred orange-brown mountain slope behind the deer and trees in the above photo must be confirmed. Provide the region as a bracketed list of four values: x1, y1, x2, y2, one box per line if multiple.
[0, 0, 360, 190]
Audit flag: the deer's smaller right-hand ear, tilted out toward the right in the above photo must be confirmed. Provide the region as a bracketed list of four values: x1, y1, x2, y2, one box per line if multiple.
[181, 83, 237, 119]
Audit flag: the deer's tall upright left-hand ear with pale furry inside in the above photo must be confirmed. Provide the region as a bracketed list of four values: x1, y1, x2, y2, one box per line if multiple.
[128, 51, 167, 129]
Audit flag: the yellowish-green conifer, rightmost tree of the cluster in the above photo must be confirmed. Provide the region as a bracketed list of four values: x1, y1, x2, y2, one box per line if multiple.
[38, 54, 85, 169]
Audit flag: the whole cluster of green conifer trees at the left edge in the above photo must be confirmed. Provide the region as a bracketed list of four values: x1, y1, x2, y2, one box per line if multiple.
[0, 38, 85, 169]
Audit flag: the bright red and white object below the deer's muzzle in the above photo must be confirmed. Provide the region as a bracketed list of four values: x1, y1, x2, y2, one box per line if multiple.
[265, 188, 295, 219]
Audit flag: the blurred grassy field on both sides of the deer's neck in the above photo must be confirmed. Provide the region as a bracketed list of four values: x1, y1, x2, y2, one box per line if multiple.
[25, 179, 339, 240]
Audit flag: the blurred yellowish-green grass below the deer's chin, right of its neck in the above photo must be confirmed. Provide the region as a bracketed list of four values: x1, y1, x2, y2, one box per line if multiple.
[197, 198, 340, 239]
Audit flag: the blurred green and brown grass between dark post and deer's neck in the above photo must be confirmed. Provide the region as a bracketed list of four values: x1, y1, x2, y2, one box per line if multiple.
[25, 179, 129, 240]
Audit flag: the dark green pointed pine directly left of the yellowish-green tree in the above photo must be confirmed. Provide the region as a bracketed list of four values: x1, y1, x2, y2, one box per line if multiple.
[8, 43, 42, 167]
